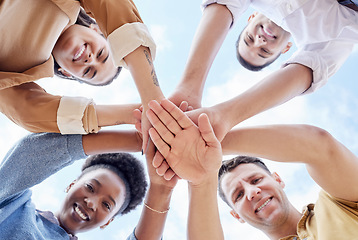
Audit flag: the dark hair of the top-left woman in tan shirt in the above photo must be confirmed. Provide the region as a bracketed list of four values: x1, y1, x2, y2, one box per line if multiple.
[53, 8, 122, 86]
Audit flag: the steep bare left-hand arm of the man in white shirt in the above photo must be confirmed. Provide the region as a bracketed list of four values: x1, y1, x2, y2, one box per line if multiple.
[169, 3, 233, 108]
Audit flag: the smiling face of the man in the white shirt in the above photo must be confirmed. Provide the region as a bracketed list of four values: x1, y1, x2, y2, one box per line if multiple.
[237, 13, 292, 66]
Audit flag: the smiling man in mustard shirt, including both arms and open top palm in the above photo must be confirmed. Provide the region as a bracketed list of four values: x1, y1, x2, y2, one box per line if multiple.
[147, 100, 358, 240]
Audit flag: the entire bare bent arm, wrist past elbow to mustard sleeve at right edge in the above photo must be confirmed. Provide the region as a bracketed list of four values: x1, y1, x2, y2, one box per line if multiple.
[222, 125, 358, 201]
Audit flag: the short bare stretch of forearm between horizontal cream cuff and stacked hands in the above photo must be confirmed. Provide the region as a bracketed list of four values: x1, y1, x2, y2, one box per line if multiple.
[95, 103, 140, 127]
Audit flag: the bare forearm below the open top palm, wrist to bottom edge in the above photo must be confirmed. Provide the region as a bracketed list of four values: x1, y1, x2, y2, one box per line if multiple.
[188, 174, 224, 240]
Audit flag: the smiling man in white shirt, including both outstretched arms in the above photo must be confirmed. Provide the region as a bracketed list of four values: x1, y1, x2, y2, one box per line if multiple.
[169, 0, 358, 144]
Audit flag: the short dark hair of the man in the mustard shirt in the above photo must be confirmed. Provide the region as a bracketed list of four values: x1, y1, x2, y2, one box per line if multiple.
[218, 156, 271, 207]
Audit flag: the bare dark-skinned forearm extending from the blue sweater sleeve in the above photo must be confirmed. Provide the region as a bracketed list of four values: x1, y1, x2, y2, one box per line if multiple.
[82, 130, 142, 155]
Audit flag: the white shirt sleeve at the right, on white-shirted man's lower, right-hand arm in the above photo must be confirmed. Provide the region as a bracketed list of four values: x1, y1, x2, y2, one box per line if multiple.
[283, 41, 354, 94]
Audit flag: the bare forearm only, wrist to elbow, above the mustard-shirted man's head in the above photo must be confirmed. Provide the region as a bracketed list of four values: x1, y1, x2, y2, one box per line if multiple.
[221, 125, 329, 163]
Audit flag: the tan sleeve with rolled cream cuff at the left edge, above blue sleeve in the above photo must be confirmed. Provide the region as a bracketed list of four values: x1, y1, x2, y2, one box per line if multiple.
[0, 82, 99, 134]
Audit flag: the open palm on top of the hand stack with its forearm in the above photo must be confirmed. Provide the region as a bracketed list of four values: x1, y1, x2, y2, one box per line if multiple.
[147, 100, 224, 240]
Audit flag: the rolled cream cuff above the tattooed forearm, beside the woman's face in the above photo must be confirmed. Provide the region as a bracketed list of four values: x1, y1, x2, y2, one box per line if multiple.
[108, 22, 156, 67]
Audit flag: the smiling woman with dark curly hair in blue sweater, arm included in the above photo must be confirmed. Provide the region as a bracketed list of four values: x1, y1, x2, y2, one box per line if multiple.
[0, 132, 147, 240]
